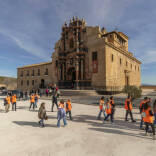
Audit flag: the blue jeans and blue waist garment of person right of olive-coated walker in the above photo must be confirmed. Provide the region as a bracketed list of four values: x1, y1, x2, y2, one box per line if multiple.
[57, 109, 67, 127]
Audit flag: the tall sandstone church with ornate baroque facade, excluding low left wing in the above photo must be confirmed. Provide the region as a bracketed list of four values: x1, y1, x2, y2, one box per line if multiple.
[18, 17, 141, 92]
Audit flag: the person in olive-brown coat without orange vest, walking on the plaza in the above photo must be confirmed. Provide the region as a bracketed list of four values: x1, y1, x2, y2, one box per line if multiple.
[38, 103, 48, 127]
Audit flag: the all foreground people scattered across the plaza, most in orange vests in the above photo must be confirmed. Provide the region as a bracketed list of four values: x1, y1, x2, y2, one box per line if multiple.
[1, 87, 156, 140]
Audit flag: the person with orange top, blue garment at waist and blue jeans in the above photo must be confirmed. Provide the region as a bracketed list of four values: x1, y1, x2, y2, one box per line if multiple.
[57, 100, 67, 127]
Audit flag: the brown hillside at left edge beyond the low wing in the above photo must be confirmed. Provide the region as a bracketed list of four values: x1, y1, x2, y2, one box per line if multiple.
[0, 76, 17, 90]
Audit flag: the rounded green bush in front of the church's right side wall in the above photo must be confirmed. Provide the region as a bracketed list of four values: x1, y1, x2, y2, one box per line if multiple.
[123, 86, 142, 99]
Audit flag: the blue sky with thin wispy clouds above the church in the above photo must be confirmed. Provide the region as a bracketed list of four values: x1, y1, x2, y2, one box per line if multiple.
[0, 0, 156, 85]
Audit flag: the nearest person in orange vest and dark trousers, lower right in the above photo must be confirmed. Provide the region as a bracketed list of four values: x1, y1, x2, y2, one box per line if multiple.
[142, 102, 156, 140]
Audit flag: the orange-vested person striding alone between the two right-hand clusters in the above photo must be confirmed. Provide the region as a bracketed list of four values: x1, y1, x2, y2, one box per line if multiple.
[125, 96, 136, 122]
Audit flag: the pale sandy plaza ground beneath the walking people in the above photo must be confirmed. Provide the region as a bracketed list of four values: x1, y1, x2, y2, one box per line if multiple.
[0, 96, 156, 156]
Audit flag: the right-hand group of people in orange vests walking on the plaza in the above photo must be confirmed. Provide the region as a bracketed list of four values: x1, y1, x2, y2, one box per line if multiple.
[97, 96, 156, 140]
